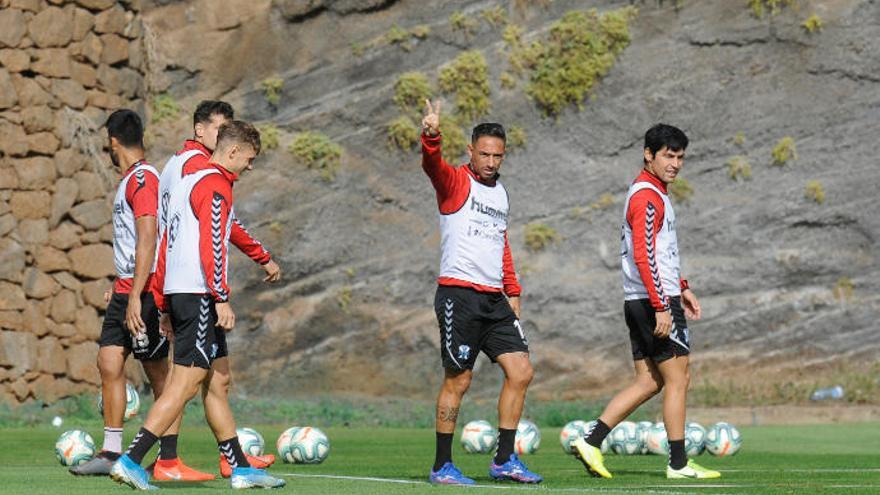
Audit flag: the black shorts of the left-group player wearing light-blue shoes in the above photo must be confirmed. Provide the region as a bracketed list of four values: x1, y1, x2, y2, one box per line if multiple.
[168, 294, 229, 370]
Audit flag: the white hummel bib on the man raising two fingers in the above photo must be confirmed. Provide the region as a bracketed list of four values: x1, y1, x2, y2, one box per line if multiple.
[440, 176, 509, 289]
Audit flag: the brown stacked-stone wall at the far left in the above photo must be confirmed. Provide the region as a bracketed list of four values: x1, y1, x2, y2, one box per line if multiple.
[0, 0, 146, 402]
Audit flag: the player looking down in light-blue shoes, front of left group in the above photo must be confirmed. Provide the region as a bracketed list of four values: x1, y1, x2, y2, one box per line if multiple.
[110, 121, 285, 490]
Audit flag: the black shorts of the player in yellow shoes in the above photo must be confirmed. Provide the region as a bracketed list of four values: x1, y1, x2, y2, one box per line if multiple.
[623, 296, 691, 363]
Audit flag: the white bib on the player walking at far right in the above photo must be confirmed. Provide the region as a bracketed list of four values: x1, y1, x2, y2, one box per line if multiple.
[621, 181, 681, 304]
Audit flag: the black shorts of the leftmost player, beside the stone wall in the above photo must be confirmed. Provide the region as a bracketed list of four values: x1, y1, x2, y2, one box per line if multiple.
[98, 292, 168, 361]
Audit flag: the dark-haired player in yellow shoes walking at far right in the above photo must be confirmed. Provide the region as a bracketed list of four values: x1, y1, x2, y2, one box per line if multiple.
[573, 124, 721, 478]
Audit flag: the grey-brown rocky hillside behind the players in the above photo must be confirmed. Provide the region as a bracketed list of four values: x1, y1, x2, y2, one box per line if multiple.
[0, 0, 880, 406]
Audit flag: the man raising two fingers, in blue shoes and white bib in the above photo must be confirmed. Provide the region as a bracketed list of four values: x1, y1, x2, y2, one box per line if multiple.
[422, 101, 543, 484]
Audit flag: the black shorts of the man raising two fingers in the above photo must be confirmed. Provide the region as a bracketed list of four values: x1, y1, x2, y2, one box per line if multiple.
[434, 285, 529, 370]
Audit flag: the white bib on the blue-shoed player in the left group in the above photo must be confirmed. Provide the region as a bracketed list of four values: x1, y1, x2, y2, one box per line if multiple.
[163, 169, 233, 294]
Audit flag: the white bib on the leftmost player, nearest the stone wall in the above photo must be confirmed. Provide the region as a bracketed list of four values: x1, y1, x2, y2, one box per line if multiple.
[113, 162, 159, 279]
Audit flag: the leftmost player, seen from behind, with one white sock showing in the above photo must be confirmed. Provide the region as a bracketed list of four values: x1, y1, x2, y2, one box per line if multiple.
[70, 110, 205, 479]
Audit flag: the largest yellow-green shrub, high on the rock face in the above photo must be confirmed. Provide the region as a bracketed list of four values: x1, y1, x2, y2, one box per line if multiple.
[505, 7, 638, 115]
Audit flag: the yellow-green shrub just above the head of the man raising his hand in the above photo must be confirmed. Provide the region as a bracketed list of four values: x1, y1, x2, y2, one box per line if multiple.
[440, 50, 490, 120]
